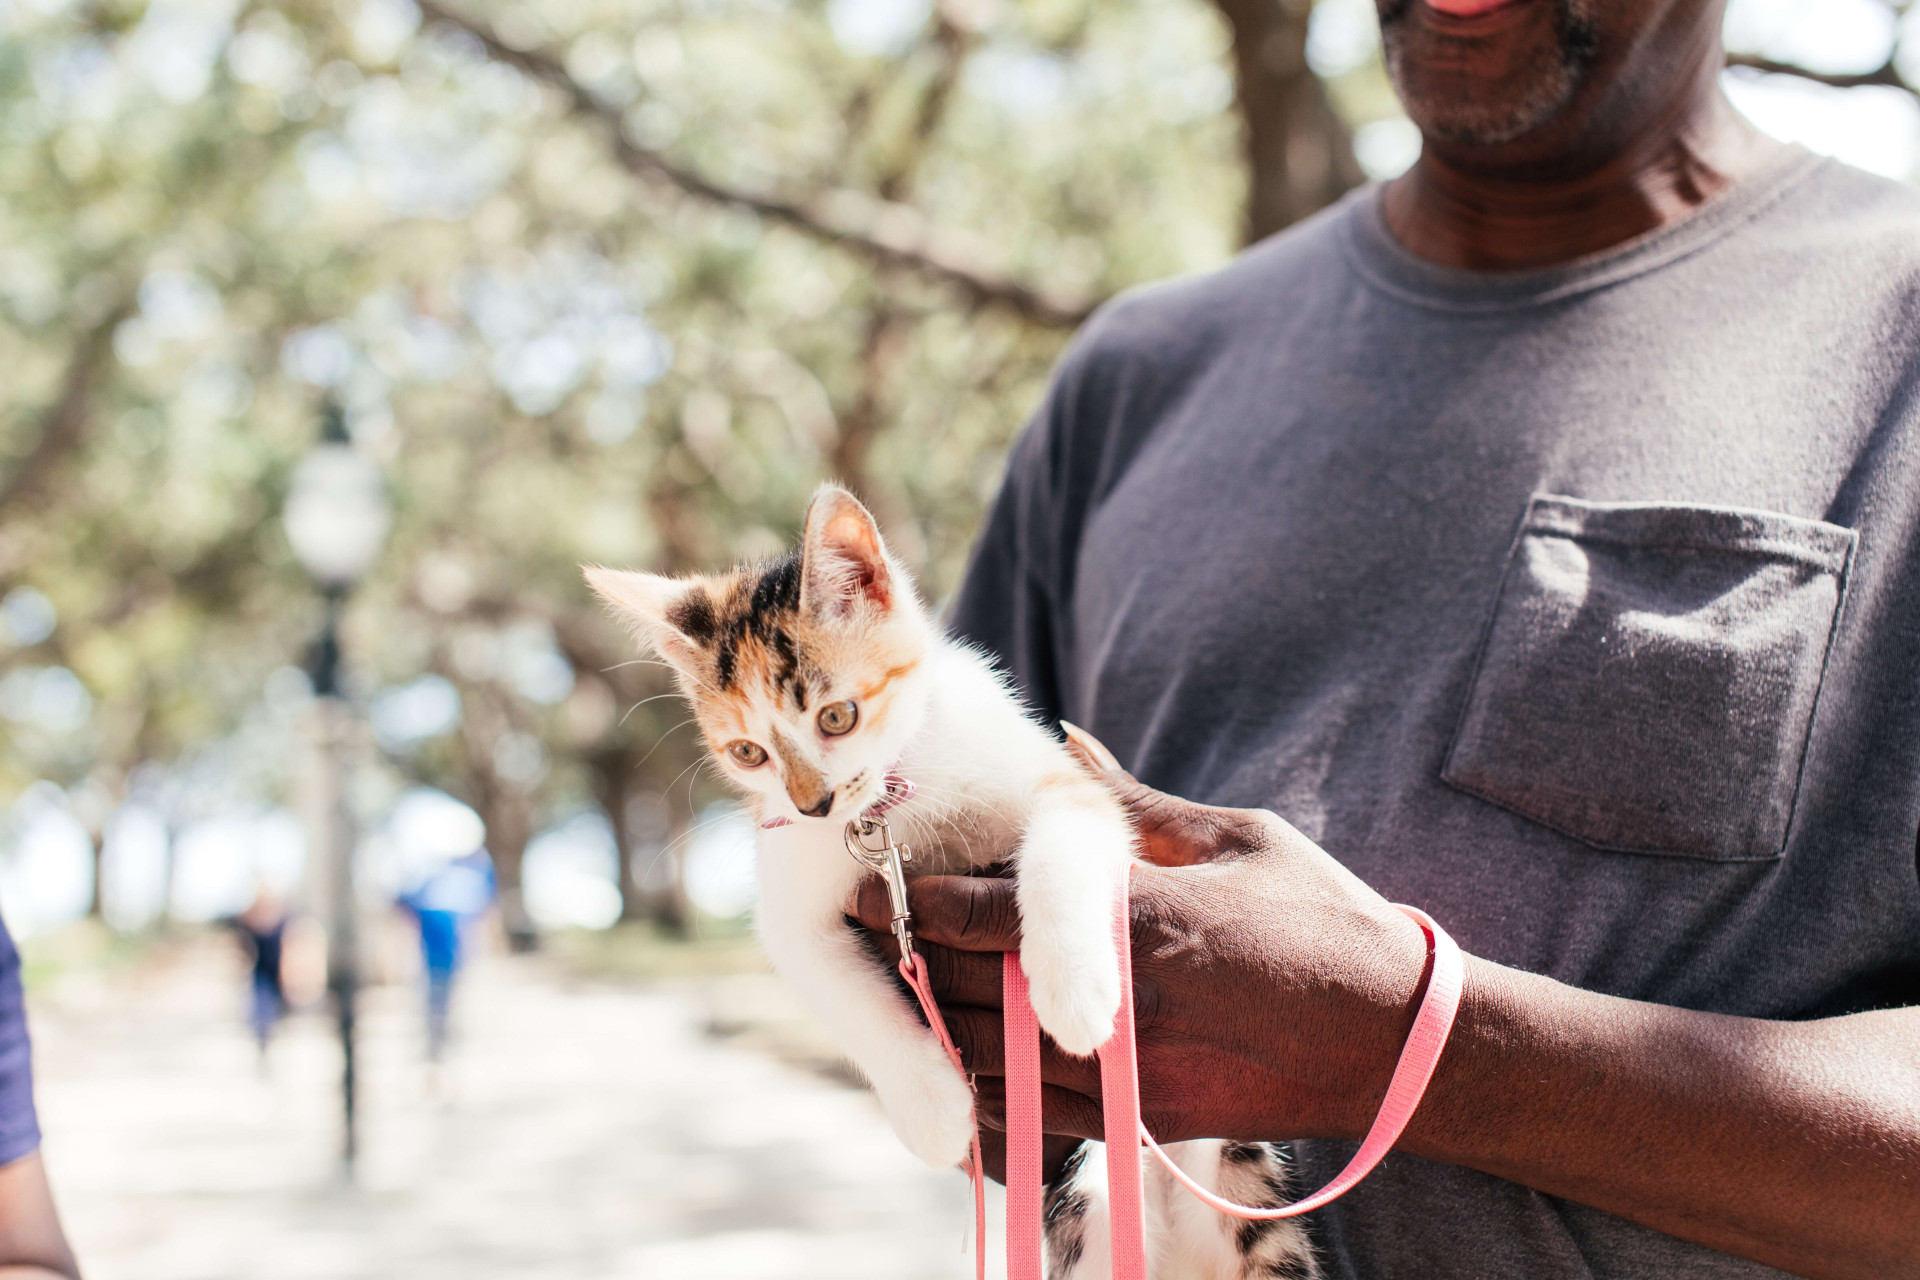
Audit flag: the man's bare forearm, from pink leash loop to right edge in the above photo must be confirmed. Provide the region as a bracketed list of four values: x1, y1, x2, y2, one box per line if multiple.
[1402, 960, 1920, 1280]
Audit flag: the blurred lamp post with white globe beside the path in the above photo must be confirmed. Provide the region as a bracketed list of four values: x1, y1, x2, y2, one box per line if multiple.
[282, 401, 394, 1176]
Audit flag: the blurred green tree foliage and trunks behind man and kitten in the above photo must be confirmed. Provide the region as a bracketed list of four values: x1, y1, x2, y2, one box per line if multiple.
[0, 0, 1905, 938]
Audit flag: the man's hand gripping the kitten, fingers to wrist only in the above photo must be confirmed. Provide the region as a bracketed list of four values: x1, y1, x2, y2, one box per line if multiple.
[856, 775, 1427, 1142]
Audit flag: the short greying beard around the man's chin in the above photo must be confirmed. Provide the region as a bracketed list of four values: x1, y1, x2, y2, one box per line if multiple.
[1380, 0, 1594, 146]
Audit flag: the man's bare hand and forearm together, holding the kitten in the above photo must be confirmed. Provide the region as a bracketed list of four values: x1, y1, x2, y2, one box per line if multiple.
[852, 771, 1920, 1280]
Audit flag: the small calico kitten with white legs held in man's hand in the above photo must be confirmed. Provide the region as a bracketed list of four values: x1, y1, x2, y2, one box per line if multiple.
[586, 486, 1317, 1280]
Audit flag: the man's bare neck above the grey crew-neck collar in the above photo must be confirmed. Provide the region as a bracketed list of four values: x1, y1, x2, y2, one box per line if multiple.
[1382, 73, 1780, 271]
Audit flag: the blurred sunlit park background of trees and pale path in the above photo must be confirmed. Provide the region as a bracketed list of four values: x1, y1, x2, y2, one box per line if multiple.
[0, 0, 1920, 1278]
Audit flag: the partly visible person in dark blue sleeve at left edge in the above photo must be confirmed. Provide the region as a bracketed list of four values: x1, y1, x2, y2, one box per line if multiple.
[0, 905, 81, 1280]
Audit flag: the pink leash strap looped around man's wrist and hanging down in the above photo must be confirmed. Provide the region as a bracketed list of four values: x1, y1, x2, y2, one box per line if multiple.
[998, 867, 1465, 1280]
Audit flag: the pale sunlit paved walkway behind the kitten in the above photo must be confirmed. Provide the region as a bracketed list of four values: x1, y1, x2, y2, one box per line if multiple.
[35, 940, 1006, 1280]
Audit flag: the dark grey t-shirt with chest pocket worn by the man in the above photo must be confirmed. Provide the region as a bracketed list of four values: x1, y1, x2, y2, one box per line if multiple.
[954, 148, 1920, 1280]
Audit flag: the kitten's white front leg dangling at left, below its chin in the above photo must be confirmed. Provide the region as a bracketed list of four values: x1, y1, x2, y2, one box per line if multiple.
[755, 837, 973, 1169]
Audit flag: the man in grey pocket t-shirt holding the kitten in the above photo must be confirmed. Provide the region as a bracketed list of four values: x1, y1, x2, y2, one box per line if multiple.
[856, 0, 1920, 1280]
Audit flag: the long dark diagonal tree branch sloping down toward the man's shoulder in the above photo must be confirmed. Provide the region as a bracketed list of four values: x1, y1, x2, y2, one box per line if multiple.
[417, 0, 1096, 328]
